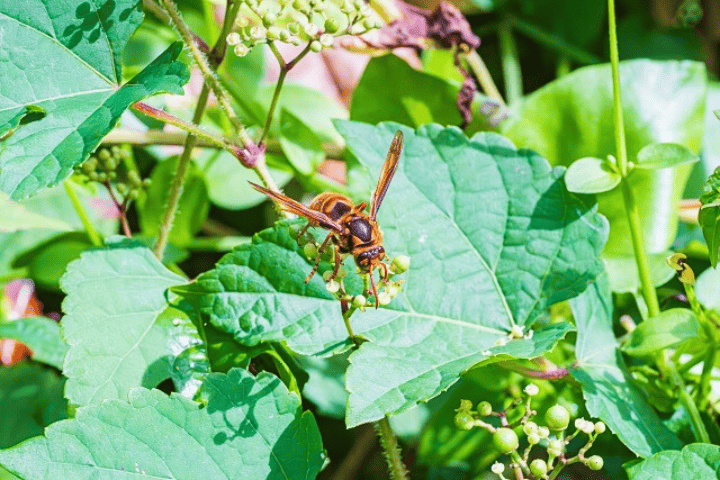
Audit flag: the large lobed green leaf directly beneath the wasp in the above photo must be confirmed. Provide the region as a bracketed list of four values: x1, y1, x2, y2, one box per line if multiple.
[175, 122, 607, 425]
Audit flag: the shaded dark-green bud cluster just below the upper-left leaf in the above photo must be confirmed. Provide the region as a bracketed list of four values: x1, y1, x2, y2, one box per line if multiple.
[75, 146, 150, 203]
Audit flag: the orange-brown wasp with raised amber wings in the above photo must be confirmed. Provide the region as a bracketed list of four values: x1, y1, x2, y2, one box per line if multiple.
[250, 130, 403, 308]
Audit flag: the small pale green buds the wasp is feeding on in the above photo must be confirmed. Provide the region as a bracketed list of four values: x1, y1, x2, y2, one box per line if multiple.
[290, 225, 410, 311]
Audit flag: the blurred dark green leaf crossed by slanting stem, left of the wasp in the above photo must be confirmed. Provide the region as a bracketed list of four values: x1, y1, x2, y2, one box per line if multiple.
[138, 156, 210, 247]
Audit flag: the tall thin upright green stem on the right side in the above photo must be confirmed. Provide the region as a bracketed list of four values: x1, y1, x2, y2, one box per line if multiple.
[608, 0, 710, 443]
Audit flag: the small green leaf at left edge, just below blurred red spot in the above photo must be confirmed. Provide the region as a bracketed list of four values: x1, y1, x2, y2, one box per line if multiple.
[0, 317, 67, 370]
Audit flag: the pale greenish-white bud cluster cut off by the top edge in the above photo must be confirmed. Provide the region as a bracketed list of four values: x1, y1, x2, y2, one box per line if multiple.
[227, 0, 382, 57]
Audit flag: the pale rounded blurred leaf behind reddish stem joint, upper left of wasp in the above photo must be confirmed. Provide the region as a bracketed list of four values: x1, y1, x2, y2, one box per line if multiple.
[196, 151, 293, 210]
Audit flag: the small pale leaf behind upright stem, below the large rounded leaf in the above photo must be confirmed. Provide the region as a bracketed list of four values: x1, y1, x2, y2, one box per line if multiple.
[602, 251, 677, 294]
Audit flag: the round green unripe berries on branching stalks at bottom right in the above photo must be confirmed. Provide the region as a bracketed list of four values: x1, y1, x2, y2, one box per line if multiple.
[455, 384, 606, 480]
